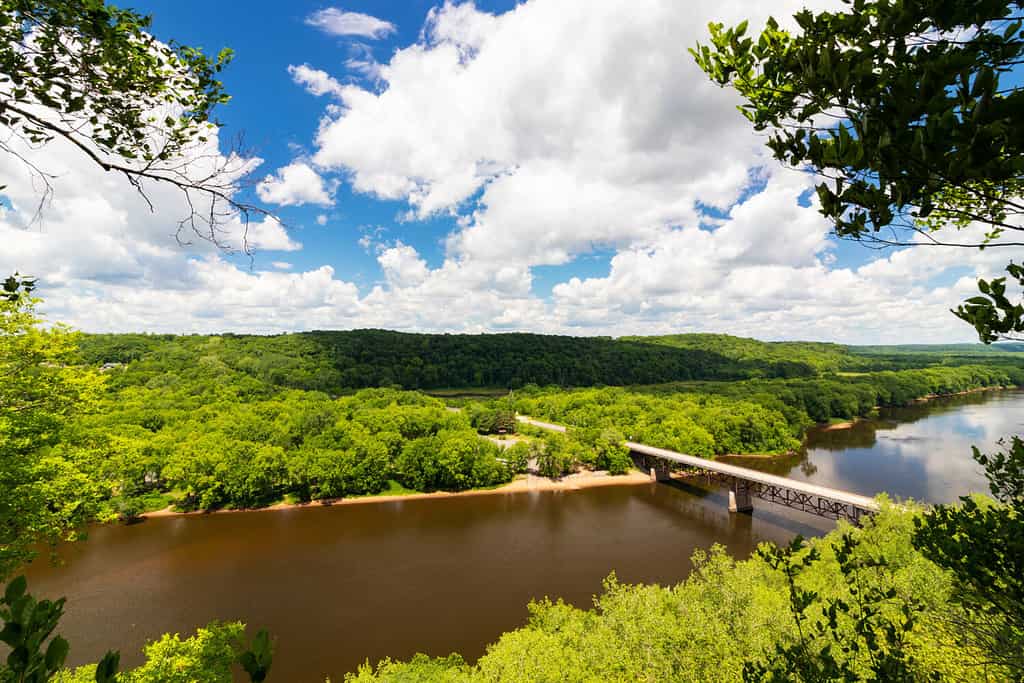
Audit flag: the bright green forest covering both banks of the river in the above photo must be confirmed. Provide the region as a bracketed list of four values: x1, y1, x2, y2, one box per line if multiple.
[8, 241, 1024, 683]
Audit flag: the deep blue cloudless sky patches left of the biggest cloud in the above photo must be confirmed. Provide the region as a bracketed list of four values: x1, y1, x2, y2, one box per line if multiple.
[132, 0, 524, 289]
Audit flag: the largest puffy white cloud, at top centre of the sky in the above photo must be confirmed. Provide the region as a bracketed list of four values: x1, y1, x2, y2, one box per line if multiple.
[314, 0, 835, 263]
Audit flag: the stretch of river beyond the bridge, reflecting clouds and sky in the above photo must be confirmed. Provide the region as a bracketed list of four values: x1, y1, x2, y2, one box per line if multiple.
[730, 390, 1024, 503]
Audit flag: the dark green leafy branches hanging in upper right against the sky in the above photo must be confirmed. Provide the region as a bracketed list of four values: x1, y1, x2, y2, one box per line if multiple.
[691, 0, 1024, 342]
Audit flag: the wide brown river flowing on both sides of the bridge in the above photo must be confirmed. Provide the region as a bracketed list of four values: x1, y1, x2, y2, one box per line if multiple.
[29, 391, 1024, 681]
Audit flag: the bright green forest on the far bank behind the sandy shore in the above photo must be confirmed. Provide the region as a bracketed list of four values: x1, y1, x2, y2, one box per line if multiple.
[12, 321, 1024, 519]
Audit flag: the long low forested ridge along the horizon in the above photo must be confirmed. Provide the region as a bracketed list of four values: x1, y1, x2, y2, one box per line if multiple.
[81, 330, 1024, 394]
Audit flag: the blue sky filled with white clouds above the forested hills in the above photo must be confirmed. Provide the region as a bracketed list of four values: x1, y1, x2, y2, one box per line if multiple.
[0, 0, 1007, 344]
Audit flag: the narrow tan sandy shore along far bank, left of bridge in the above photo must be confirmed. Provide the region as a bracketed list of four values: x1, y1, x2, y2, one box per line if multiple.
[139, 470, 650, 517]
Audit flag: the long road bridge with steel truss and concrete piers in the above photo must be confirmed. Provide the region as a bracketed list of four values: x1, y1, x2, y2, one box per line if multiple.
[516, 415, 879, 524]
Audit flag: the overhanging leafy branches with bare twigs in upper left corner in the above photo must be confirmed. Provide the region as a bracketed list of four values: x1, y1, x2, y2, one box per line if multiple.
[0, 0, 266, 244]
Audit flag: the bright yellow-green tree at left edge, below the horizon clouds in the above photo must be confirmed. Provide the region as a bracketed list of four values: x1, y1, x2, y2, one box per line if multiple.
[0, 278, 101, 578]
